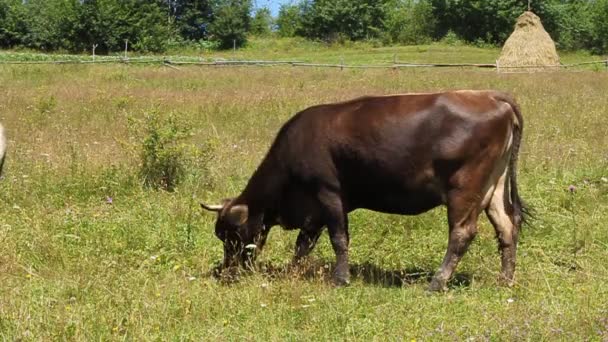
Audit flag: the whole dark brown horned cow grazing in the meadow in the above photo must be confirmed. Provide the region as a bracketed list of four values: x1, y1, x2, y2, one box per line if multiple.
[201, 90, 524, 290]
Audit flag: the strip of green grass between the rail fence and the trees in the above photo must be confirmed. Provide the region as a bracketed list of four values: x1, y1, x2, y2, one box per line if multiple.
[0, 37, 606, 70]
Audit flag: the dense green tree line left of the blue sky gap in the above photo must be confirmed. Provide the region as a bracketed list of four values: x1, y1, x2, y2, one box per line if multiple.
[0, 0, 252, 52]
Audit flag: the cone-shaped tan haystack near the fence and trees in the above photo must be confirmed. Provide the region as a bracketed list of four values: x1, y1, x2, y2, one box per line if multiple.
[497, 11, 559, 72]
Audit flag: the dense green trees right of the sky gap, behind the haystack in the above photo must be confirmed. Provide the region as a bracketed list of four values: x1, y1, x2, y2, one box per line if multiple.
[277, 0, 608, 53]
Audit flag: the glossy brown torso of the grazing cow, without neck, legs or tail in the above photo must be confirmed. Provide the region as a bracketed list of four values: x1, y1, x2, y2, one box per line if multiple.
[275, 91, 512, 214]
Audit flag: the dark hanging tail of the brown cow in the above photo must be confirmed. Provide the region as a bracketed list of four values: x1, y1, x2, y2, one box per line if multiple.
[501, 97, 530, 228]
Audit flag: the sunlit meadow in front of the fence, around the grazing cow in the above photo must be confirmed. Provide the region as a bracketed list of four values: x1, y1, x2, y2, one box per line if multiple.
[0, 45, 608, 341]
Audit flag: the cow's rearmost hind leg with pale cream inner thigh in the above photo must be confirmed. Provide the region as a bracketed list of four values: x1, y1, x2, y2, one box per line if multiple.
[486, 171, 519, 285]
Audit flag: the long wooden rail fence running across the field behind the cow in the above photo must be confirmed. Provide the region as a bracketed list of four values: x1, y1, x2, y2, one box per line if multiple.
[0, 57, 608, 72]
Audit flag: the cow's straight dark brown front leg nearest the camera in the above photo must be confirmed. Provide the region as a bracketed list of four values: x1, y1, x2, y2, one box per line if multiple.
[319, 191, 350, 286]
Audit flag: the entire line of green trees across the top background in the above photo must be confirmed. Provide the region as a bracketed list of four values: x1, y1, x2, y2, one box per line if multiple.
[0, 0, 608, 54]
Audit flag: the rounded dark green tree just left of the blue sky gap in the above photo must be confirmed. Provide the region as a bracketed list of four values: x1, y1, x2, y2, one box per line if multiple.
[209, 0, 251, 49]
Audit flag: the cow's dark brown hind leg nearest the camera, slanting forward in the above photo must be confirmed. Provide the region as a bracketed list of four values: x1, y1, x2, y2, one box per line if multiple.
[429, 191, 480, 291]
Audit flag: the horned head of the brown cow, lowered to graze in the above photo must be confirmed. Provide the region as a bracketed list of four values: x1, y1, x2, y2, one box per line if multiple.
[201, 199, 264, 268]
